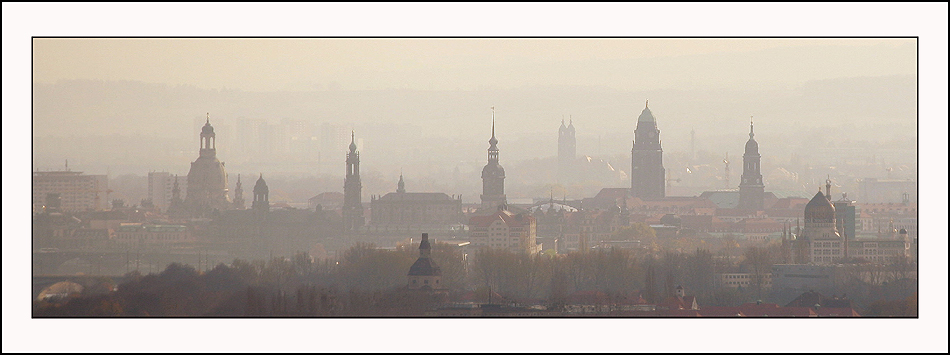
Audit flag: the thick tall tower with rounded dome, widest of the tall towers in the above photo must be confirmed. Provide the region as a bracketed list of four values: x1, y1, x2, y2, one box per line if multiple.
[630, 100, 666, 199]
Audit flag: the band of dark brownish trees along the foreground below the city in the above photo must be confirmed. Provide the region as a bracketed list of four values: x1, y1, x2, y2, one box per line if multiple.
[34, 239, 916, 316]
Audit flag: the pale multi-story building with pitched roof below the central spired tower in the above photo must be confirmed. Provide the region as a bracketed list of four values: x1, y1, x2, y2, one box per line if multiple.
[469, 207, 541, 254]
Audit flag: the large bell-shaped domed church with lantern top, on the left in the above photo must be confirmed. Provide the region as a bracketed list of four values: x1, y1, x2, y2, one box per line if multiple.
[185, 114, 231, 217]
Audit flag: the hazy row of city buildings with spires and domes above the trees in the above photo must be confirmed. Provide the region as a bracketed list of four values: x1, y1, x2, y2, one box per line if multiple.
[34, 103, 916, 262]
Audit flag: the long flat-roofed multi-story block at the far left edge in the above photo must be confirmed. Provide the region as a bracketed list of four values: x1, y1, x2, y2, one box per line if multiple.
[33, 170, 109, 213]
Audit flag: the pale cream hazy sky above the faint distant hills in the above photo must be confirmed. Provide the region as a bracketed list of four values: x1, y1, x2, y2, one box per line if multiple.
[33, 38, 917, 91]
